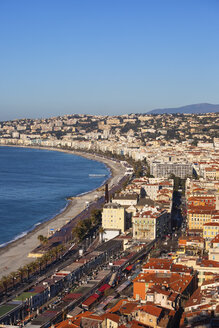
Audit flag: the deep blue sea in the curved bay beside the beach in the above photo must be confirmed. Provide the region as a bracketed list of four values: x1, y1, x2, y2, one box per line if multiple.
[0, 147, 110, 247]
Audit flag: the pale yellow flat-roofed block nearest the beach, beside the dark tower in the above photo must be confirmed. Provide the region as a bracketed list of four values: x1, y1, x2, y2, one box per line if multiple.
[102, 203, 126, 233]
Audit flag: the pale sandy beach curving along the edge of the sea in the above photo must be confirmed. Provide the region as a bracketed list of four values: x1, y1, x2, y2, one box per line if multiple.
[0, 148, 125, 278]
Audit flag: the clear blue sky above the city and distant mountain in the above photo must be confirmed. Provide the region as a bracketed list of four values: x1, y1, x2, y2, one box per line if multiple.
[0, 0, 219, 120]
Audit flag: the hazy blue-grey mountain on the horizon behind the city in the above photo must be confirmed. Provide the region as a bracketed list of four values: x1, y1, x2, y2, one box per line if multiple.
[146, 103, 219, 114]
